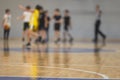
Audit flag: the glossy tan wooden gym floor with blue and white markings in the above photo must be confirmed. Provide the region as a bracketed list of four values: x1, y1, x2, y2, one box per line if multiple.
[0, 40, 120, 80]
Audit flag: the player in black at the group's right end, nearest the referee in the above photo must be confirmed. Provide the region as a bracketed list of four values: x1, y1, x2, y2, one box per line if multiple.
[63, 10, 73, 43]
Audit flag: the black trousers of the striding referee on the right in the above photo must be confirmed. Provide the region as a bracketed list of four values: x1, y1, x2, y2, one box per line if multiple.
[94, 20, 106, 41]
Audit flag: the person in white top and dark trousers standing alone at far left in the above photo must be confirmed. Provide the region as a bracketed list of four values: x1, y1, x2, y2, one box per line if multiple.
[2, 9, 11, 40]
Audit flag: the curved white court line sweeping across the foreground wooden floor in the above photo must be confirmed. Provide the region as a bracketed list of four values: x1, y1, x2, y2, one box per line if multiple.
[0, 65, 109, 79]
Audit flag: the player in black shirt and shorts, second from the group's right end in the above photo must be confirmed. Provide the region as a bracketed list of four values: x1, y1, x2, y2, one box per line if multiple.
[53, 9, 62, 43]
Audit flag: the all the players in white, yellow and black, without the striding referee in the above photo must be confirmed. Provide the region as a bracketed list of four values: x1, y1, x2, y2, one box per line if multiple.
[3, 5, 73, 46]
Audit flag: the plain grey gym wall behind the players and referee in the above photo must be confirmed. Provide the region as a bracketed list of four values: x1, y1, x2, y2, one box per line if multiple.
[0, 0, 120, 40]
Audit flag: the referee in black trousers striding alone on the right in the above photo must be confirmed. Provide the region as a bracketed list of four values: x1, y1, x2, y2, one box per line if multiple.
[94, 5, 106, 42]
